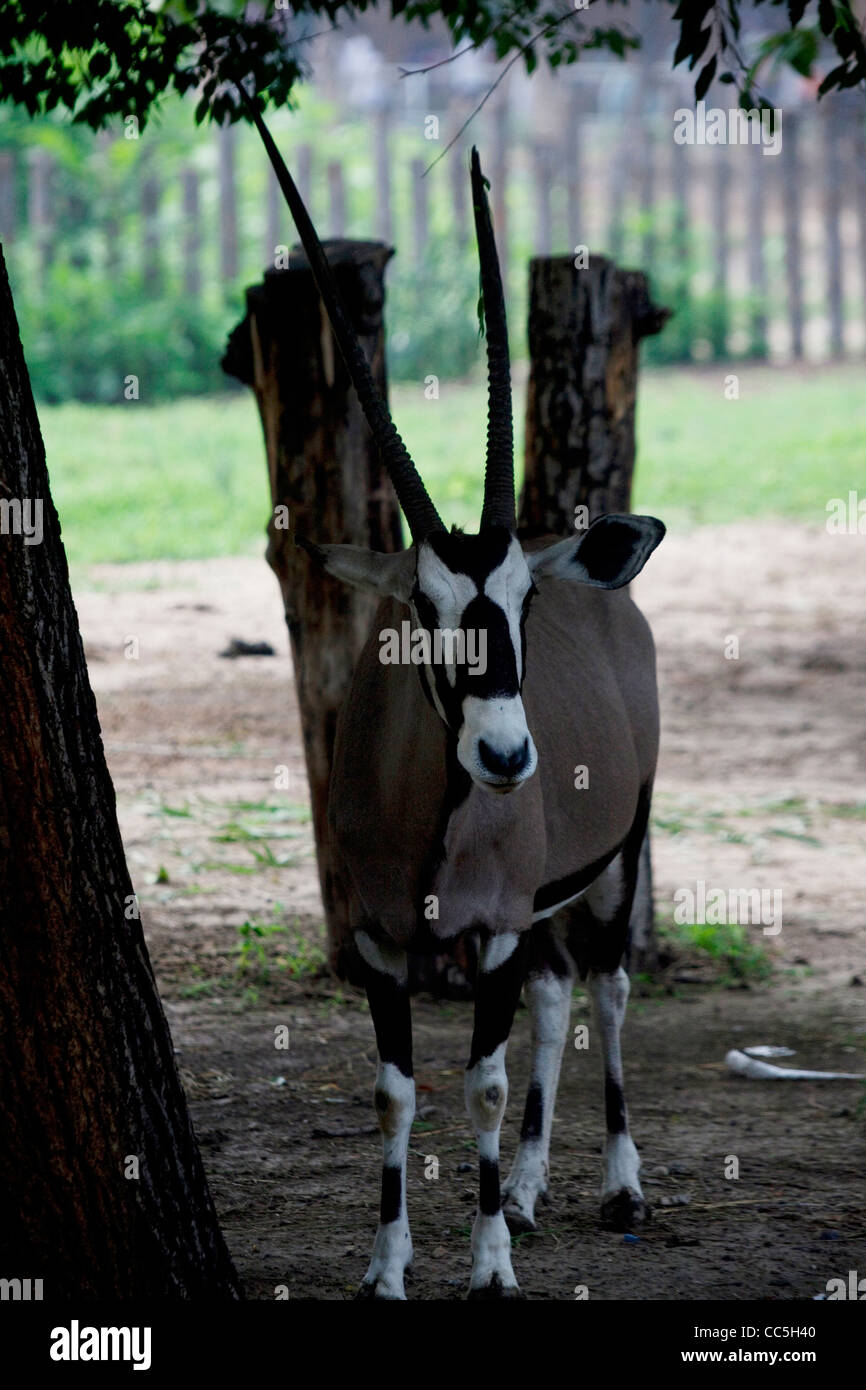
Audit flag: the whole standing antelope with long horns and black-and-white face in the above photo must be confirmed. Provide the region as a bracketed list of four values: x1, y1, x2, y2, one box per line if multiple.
[253, 111, 664, 1300]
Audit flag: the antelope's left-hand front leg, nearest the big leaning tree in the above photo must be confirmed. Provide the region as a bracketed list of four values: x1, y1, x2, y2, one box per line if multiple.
[354, 931, 416, 1298]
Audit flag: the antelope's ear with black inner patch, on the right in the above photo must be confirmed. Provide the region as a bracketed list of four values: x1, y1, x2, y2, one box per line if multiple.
[527, 513, 664, 589]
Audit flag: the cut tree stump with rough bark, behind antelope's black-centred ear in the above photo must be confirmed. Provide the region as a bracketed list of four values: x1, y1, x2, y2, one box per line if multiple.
[518, 256, 669, 535]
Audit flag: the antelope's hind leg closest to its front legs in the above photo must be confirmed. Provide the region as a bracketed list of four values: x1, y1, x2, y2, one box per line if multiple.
[502, 922, 574, 1236]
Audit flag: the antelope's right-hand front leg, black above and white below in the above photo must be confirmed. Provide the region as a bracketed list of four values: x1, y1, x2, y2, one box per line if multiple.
[466, 931, 527, 1298]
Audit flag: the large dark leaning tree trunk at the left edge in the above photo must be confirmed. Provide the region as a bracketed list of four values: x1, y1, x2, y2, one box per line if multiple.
[0, 252, 238, 1298]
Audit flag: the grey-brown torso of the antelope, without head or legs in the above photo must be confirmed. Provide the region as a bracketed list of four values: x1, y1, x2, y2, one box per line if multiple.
[329, 547, 659, 948]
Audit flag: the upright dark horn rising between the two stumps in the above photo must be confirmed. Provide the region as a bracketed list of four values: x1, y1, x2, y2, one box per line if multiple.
[471, 146, 517, 531]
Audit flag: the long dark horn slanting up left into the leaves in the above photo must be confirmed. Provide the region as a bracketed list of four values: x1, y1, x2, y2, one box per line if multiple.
[240, 97, 445, 542]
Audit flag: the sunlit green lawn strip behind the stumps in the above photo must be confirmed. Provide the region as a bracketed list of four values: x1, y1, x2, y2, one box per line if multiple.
[40, 364, 866, 567]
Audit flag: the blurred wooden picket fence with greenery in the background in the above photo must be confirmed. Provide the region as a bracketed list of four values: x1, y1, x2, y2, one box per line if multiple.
[0, 70, 866, 398]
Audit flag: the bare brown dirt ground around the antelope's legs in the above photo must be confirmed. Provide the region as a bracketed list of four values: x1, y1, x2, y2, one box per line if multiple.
[76, 523, 866, 1300]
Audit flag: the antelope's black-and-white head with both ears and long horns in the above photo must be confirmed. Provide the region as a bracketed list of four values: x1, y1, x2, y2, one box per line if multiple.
[257, 120, 664, 792]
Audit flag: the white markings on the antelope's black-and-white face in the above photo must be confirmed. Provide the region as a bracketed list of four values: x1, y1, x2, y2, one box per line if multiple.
[413, 538, 538, 792]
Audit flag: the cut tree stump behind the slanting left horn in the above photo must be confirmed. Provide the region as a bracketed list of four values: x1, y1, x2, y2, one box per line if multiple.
[222, 240, 403, 976]
